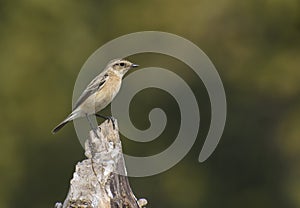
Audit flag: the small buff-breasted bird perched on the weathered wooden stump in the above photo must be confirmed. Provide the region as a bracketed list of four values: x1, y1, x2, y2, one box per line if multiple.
[52, 59, 139, 135]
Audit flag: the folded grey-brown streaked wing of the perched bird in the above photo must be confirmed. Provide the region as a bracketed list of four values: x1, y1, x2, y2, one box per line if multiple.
[73, 71, 108, 110]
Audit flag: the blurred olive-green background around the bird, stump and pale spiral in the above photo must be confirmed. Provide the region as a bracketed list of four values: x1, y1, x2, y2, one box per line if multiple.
[0, 0, 300, 208]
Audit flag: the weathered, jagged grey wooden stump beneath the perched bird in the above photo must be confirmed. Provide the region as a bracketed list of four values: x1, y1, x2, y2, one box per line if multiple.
[55, 121, 147, 208]
